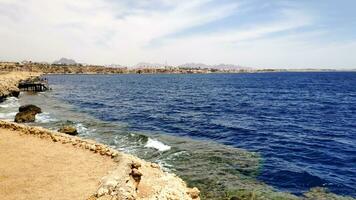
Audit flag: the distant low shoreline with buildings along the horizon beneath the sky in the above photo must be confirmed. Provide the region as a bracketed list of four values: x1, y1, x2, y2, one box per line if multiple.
[0, 62, 356, 74]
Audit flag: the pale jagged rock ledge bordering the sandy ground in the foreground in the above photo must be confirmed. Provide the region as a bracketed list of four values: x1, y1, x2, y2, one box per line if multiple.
[0, 121, 200, 200]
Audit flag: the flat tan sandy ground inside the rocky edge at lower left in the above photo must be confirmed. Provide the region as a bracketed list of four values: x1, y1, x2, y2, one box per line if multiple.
[0, 128, 115, 200]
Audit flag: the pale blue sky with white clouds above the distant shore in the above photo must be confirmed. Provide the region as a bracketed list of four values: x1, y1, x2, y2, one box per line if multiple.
[0, 0, 356, 69]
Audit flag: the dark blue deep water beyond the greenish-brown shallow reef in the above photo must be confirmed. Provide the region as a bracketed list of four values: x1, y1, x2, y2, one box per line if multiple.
[48, 72, 356, 196]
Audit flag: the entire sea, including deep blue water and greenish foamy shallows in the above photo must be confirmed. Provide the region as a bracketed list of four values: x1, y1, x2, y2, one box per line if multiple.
[0, 72, 356, 197]
